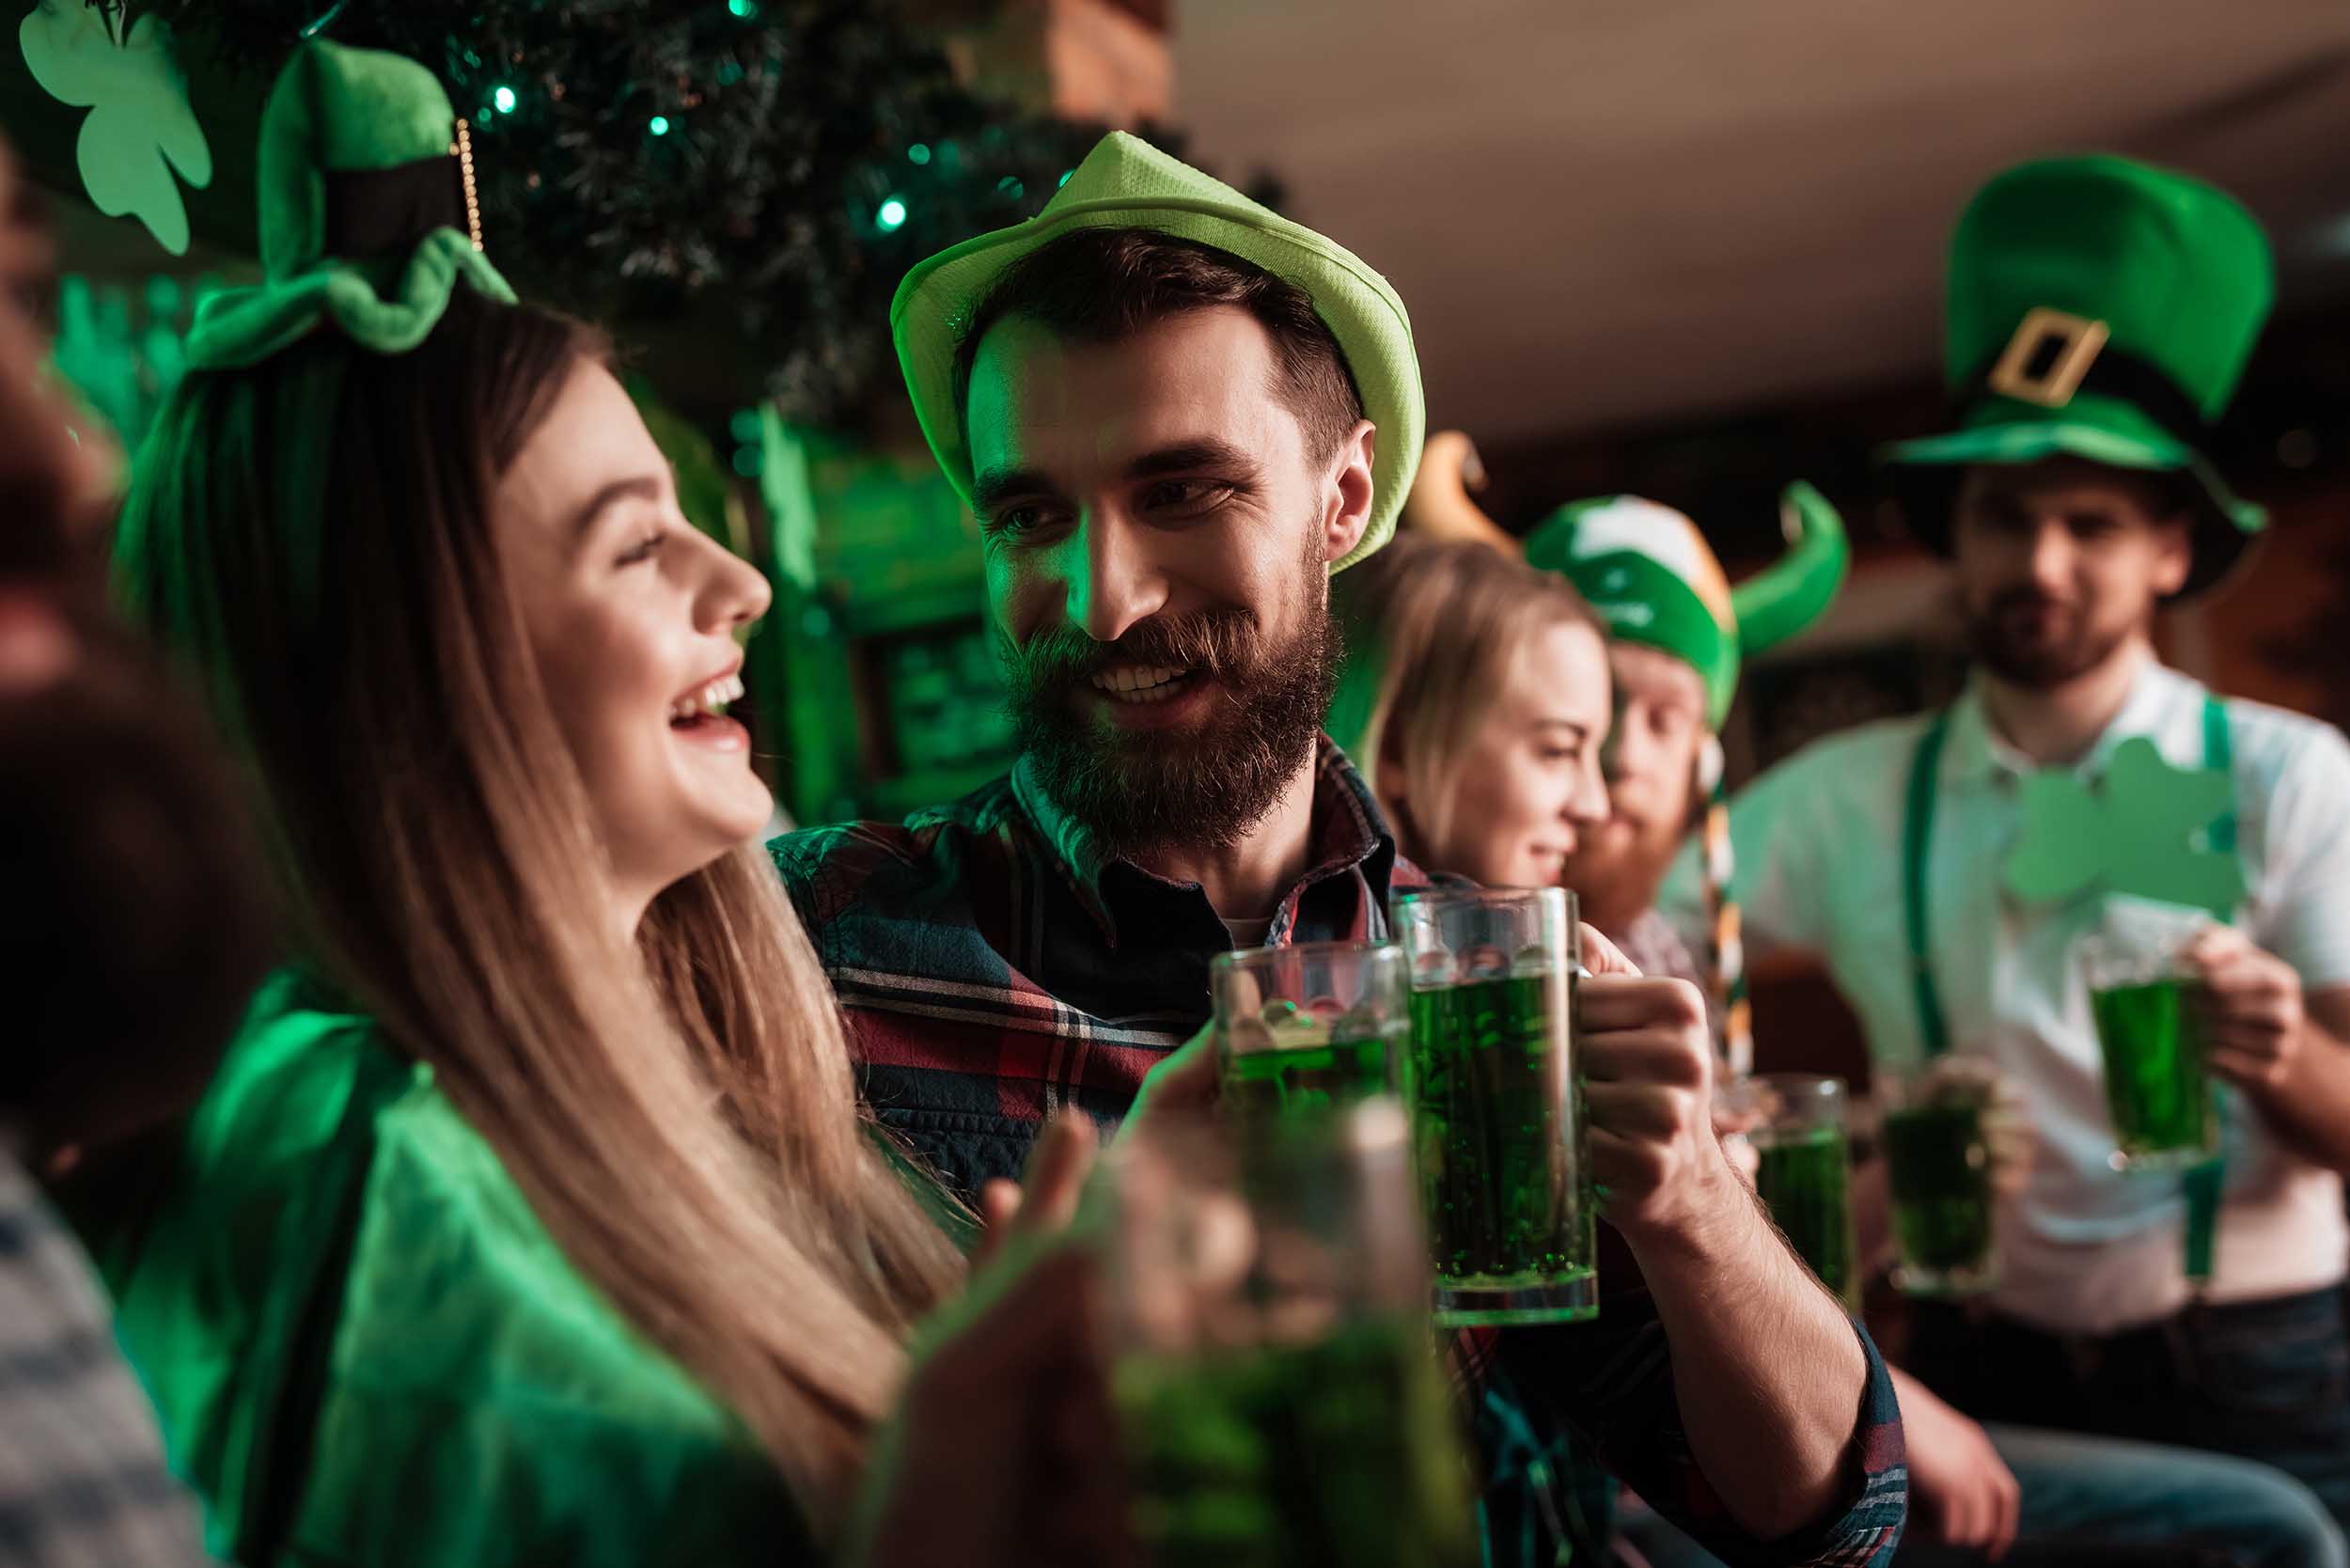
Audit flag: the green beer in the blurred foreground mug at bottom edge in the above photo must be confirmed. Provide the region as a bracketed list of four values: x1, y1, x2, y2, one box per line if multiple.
[1112, 1319, 1476, 1568]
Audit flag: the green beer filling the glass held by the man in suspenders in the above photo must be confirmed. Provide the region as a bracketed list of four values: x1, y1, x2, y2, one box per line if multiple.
[2090, 976, 2218, 1170]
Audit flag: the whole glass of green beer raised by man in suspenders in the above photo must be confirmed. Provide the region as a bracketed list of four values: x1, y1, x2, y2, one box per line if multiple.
[2080, 917, 2218, 1173]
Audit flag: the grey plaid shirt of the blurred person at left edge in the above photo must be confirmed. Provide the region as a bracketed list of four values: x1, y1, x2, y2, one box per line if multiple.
[0, 1150, 212, 1568]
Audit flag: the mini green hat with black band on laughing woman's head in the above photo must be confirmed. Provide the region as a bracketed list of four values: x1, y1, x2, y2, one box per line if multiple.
[188, 40, 515, 369]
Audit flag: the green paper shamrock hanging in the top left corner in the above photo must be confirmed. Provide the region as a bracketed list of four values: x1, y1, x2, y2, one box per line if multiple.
[17, 0, 212, 257]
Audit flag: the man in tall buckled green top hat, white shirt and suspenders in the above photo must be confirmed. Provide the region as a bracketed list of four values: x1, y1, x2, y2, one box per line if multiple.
[1701, 158, 2350, 1532]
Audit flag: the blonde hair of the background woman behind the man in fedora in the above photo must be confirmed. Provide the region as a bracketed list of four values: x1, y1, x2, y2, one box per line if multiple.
[1330, 531, 1606, 858]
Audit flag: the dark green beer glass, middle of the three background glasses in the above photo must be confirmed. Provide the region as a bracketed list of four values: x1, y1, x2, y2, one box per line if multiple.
[1878, 1058, 2000, 1295]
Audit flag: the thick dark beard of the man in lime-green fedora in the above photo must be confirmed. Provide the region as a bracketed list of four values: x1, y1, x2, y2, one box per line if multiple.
[1001, 575, 1340, 858]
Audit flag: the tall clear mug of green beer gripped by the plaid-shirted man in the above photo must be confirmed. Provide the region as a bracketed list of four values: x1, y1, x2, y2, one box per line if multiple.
[1396, 888, 1601, 1325]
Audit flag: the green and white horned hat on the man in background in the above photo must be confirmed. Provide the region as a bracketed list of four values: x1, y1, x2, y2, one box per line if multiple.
[1526, 482, 1852, 731]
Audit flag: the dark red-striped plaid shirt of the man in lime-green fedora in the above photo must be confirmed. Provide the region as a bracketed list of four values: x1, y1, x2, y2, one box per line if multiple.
[769, 738, 1906, 1568]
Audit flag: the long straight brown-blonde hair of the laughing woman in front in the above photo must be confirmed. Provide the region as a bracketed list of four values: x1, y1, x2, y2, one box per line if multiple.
[118, 291, 962, 1530]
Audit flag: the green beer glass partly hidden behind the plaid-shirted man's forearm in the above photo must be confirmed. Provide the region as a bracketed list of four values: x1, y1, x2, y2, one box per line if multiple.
[1732, 1072, 1861, 1311]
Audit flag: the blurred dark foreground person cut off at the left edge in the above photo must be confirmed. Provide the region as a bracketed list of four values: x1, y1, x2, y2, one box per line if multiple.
[0, 134, 266, 1568]
